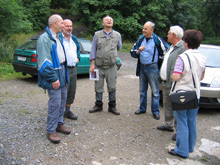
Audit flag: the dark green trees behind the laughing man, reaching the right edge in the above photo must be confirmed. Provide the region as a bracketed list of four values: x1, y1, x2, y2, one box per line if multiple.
[70, 0, 220, 40]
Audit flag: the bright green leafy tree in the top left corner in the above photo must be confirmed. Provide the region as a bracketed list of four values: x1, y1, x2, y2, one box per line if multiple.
[0, 0, 32, 36]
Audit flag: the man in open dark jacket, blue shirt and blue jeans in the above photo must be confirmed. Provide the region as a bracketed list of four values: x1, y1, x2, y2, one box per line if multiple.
[130, 21, 169, 120]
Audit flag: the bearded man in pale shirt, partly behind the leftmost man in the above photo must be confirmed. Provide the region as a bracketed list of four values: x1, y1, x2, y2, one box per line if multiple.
[60, 19, 80, 120]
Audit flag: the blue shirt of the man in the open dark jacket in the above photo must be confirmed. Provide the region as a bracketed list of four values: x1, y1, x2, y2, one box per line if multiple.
[140, 36, 158, 65]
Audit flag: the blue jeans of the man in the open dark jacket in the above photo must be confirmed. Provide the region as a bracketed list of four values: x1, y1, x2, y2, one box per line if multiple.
[139, 63, 160, 114]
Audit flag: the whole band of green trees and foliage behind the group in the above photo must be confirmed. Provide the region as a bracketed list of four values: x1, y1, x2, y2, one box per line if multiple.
[0, 0, 220, 76]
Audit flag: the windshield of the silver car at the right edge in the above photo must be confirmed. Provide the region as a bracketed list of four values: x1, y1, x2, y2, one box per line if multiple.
[198, 47, 220, 68]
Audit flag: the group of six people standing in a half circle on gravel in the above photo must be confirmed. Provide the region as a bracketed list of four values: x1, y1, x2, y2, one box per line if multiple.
[37, 15, 206, 158]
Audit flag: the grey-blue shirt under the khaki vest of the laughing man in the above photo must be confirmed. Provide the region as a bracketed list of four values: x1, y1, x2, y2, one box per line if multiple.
[89, 30, 122, 60]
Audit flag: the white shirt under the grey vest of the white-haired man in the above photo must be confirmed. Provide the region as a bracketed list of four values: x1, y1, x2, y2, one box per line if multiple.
[160, 45, 174, 81]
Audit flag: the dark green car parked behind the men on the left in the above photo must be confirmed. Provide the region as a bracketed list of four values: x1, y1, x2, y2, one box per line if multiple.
[12, 38, 122, 76]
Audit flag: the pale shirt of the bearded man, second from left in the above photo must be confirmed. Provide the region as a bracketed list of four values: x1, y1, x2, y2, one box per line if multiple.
[63, 35, 77, 66]
